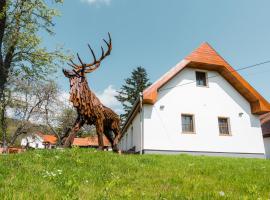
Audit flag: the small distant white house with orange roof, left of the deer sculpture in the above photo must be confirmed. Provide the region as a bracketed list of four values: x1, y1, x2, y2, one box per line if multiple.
[21, 132, 57, 149]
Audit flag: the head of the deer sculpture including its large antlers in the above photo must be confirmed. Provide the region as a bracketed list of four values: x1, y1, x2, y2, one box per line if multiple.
[63, 33, 112, 87]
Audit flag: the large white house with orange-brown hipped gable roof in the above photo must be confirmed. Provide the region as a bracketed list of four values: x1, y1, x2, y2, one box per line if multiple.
[119, 43, 270, 158]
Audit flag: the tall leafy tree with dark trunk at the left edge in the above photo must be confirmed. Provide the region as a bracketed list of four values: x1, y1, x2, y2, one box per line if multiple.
[0, 0, 65, 147]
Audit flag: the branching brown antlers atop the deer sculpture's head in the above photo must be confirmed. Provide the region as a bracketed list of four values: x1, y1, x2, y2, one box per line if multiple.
[68, 33, 112, 73]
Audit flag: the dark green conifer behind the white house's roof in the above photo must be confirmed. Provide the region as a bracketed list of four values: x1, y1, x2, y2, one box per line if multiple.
[116, 67, 151, 124]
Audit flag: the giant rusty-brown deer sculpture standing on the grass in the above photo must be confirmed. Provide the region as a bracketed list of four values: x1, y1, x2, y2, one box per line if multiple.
[63, 33, 120, 151]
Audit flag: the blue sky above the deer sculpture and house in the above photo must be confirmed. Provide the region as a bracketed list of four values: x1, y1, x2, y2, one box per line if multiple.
[43, 0, 270, 111]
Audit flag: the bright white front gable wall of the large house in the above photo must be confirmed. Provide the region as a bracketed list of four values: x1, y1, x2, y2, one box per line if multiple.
[142, 68, 265, 154]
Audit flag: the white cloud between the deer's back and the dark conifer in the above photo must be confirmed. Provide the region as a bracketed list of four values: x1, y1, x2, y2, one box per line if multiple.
[97, 85, 123, 114]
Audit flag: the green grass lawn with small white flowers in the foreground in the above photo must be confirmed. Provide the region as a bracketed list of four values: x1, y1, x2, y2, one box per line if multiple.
[0, 148, 270, 200]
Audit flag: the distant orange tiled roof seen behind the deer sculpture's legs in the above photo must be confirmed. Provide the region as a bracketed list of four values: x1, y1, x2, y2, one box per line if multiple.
[72, 135, 111, 147]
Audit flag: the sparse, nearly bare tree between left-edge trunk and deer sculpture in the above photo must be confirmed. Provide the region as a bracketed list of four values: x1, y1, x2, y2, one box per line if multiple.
[6, 78, 58, 145]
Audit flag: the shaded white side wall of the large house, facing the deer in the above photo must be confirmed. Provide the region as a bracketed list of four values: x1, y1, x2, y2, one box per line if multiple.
[119, 113, 141, 152]
